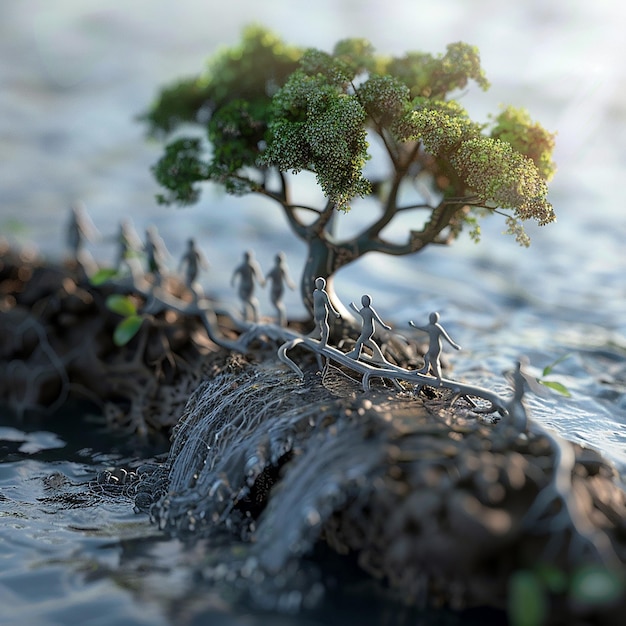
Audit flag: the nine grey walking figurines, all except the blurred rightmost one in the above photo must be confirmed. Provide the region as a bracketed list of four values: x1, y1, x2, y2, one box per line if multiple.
[68, 205, 461, 379]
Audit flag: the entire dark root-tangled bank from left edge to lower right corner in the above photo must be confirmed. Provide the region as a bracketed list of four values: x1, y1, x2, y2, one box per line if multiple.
[0, 244, 626, 624]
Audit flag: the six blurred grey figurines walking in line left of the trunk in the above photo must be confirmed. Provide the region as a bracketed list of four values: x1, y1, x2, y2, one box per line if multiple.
[67, 204, 296, 326]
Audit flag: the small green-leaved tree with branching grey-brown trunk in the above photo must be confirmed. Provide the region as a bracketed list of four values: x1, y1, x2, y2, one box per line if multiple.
[142, 27, 555, 311]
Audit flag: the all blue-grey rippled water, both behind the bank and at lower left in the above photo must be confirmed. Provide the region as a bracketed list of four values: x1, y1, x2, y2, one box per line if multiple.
[0, 0, 626, 624]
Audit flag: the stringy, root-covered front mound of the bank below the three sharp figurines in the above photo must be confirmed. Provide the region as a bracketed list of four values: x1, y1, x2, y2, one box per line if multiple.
[137, 362, 626, 624]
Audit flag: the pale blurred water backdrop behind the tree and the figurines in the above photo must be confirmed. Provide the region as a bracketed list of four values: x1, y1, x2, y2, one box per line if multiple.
[0, 0, 626, 461]
